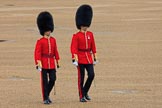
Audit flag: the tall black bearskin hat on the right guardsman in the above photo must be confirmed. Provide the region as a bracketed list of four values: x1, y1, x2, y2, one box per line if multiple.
[75, 4, 93, 29]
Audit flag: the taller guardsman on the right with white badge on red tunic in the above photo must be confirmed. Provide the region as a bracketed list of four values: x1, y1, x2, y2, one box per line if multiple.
[71, 5, 97, 102]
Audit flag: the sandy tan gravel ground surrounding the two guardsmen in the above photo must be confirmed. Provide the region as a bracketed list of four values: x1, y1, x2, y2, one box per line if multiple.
[0, 0, 162, 108]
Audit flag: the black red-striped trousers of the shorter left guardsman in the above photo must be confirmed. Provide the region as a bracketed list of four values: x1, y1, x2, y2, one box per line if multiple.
[41, 69, 56, 100]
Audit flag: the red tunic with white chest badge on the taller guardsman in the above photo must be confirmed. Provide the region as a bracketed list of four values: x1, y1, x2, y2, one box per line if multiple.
[71, 31, 96, 64]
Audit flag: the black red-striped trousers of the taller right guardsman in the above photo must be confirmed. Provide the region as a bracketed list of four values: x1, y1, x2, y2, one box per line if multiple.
[78, 64, 95, 99]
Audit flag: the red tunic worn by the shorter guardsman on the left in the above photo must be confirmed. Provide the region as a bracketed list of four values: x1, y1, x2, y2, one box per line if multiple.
[34, 37, 60, 69]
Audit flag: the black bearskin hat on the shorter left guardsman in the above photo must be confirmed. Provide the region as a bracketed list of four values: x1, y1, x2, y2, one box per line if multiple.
[37, 11, 54, 36]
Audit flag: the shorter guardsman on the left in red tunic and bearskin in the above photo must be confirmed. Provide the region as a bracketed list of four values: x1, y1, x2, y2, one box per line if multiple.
[34, 11, 60, 104]
